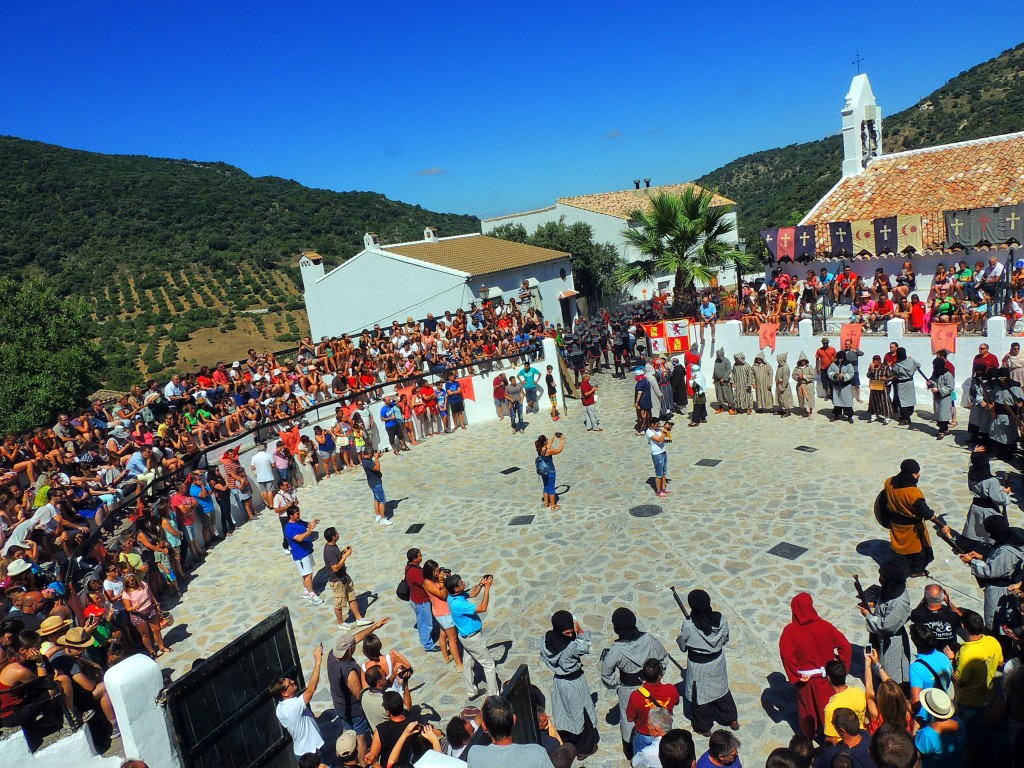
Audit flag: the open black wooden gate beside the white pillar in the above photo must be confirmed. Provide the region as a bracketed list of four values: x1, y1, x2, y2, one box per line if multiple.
[167, 608, 305, 768]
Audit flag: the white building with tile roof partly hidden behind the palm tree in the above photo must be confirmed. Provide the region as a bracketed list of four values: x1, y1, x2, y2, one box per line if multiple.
[480, 179, 739, 298]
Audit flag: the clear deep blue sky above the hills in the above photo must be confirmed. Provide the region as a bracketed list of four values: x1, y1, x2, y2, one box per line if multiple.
[6, 0, 1024, 216]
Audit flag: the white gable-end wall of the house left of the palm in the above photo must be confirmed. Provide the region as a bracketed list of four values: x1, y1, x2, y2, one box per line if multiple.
[305, 250, 473, 339]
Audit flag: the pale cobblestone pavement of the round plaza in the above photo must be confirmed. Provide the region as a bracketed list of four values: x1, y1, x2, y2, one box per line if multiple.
[161, 362, 1021, 766]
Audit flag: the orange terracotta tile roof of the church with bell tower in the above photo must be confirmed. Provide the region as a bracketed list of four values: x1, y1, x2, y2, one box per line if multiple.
[801, 132, 1024, 253]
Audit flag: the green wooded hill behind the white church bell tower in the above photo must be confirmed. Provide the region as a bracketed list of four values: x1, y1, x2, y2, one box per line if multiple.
[696, 43, 1024, 247]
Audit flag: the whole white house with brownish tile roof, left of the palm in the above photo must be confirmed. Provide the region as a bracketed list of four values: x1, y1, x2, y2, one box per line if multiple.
[299, 227, 577, 339]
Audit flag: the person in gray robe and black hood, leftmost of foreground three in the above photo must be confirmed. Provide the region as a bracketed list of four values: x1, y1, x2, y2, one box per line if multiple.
[541, 610, 598, 759]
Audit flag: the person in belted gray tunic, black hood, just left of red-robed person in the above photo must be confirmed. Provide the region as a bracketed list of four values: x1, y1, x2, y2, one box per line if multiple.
[676, 590, 739, 736]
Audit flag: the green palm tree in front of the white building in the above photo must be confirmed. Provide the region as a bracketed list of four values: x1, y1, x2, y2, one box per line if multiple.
[616, 185, 757, 313]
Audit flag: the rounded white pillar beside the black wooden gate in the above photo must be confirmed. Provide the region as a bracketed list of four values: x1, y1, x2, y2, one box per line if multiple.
[103, 653, 181, 768]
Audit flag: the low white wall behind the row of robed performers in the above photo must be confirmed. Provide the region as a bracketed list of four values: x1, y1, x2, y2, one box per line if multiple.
[688, 317, 1014, 410]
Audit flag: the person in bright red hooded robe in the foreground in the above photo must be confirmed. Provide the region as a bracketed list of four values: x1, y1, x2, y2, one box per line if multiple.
[778, 592, 851, 738]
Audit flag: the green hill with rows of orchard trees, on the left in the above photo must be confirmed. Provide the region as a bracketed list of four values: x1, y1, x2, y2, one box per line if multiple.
[0, 136, 479, 387]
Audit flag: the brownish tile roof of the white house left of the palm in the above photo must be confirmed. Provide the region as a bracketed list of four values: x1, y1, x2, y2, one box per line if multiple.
[382, 234, 569, 275]
